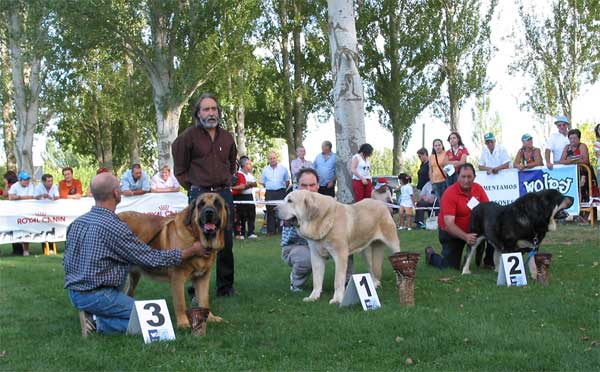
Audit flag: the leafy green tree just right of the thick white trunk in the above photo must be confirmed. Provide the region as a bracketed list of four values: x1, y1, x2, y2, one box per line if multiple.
[358, 0, 444, 174]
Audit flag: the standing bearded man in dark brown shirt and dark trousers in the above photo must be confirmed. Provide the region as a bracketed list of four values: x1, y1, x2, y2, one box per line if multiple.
[172, 93, 237, 296]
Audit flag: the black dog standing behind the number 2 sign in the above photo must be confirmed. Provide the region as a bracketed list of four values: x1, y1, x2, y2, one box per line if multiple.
[462, 190, 573, 278]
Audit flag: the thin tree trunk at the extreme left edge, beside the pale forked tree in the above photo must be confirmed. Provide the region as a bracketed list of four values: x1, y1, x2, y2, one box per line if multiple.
[0, 32, 17, 170]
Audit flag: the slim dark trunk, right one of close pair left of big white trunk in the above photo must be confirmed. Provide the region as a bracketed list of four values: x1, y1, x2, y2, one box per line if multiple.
[292, 0, 306, 147]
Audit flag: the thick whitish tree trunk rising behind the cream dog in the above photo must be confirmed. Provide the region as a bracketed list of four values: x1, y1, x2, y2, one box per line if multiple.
[327, 0, 365, 203]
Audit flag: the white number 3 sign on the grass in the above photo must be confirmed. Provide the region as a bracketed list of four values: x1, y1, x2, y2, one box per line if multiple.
[127, 300, 175, 344]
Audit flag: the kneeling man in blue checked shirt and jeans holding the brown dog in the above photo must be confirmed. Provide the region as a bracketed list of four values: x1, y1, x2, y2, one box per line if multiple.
[63, 173, 205, 337]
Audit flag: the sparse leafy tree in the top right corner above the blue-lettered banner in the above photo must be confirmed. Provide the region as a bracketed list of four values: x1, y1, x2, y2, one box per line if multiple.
[512, 0, 600, 122]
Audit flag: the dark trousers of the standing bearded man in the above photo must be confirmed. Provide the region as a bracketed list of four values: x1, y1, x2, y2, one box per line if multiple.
[188, 187, 234, 295]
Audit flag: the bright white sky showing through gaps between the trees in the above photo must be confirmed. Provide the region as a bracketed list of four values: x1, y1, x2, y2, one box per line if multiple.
[0, 1, 600, 165]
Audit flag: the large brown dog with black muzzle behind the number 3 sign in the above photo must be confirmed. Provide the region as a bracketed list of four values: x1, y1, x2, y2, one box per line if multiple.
[119, 193, 227, 327]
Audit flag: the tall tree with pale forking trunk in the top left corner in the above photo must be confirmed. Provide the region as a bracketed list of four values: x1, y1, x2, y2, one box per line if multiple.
[0, 1, 48, 173]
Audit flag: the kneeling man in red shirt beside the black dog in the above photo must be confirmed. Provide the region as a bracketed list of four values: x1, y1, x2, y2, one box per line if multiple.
[425, 163, 489, 270]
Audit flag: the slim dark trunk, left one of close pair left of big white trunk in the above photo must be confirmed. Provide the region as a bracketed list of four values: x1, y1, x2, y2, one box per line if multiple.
[279, 0, 296, 161]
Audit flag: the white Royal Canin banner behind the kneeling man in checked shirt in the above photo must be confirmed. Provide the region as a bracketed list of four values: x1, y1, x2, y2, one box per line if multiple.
[0, 193, 188, 244]
